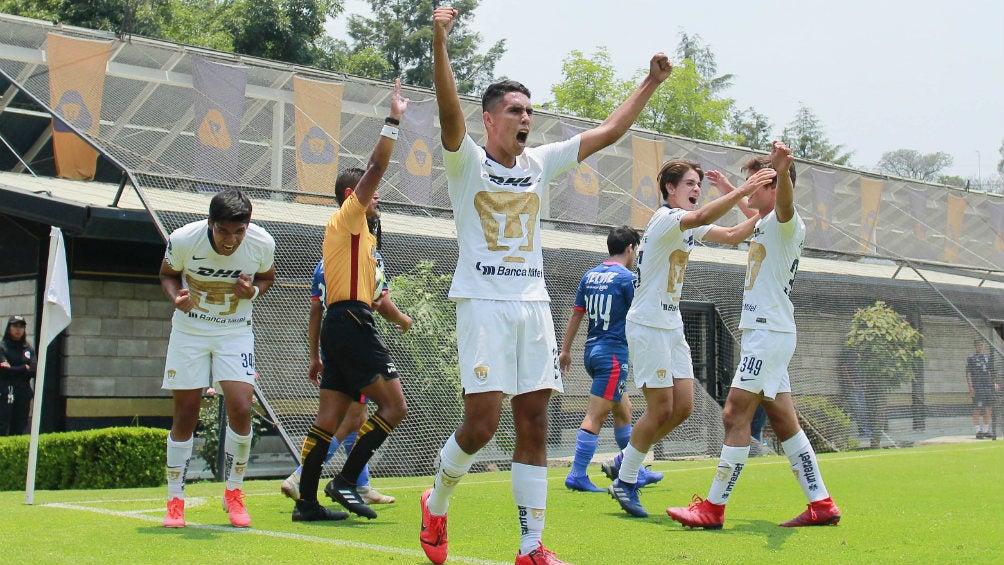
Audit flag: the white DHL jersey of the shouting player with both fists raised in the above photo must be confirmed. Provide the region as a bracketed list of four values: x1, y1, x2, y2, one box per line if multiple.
[443, 134, 579, 300]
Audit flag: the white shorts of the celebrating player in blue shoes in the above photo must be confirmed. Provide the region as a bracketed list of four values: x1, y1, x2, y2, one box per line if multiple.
[624, 320, 694, 388]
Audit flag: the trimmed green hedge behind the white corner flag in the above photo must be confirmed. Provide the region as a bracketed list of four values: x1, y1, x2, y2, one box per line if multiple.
[0, 428, 168, 491]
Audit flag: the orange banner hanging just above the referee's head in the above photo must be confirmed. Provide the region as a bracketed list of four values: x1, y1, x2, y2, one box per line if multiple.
[293, 76, 345, 205]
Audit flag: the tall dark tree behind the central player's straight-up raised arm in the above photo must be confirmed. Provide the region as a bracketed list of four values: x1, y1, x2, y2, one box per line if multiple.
[347, 0, 505, 94]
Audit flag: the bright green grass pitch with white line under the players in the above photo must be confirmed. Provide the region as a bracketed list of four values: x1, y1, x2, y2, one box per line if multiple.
[0, 442, 1004, 565]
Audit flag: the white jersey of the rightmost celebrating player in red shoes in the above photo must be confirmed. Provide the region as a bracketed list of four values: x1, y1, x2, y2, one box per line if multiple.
[739, 211, 805, 333]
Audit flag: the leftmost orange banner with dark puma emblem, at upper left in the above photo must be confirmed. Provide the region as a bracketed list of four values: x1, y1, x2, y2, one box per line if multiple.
[45, 33, 111, 181]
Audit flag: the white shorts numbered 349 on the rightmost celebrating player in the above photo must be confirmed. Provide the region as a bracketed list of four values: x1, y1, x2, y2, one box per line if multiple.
[732, 329, 796, 398]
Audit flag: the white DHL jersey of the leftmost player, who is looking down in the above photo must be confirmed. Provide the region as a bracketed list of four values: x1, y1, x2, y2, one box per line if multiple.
[164, 220, 275, 335]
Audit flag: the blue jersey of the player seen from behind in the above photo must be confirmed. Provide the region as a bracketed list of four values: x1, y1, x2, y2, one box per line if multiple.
[572, 261, 635, 347]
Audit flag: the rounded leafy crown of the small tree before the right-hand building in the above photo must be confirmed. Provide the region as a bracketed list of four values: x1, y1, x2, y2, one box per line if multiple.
[846, 300, 924, 391]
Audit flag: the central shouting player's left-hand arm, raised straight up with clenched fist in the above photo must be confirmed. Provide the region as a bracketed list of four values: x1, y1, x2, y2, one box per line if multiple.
[433, 6, 467, 153]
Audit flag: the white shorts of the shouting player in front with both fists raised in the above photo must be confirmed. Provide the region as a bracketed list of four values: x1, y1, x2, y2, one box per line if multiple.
[457, 298, 563, 394]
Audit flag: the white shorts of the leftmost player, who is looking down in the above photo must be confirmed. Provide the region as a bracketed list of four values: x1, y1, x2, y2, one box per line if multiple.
[161, 328, 255, 390]
